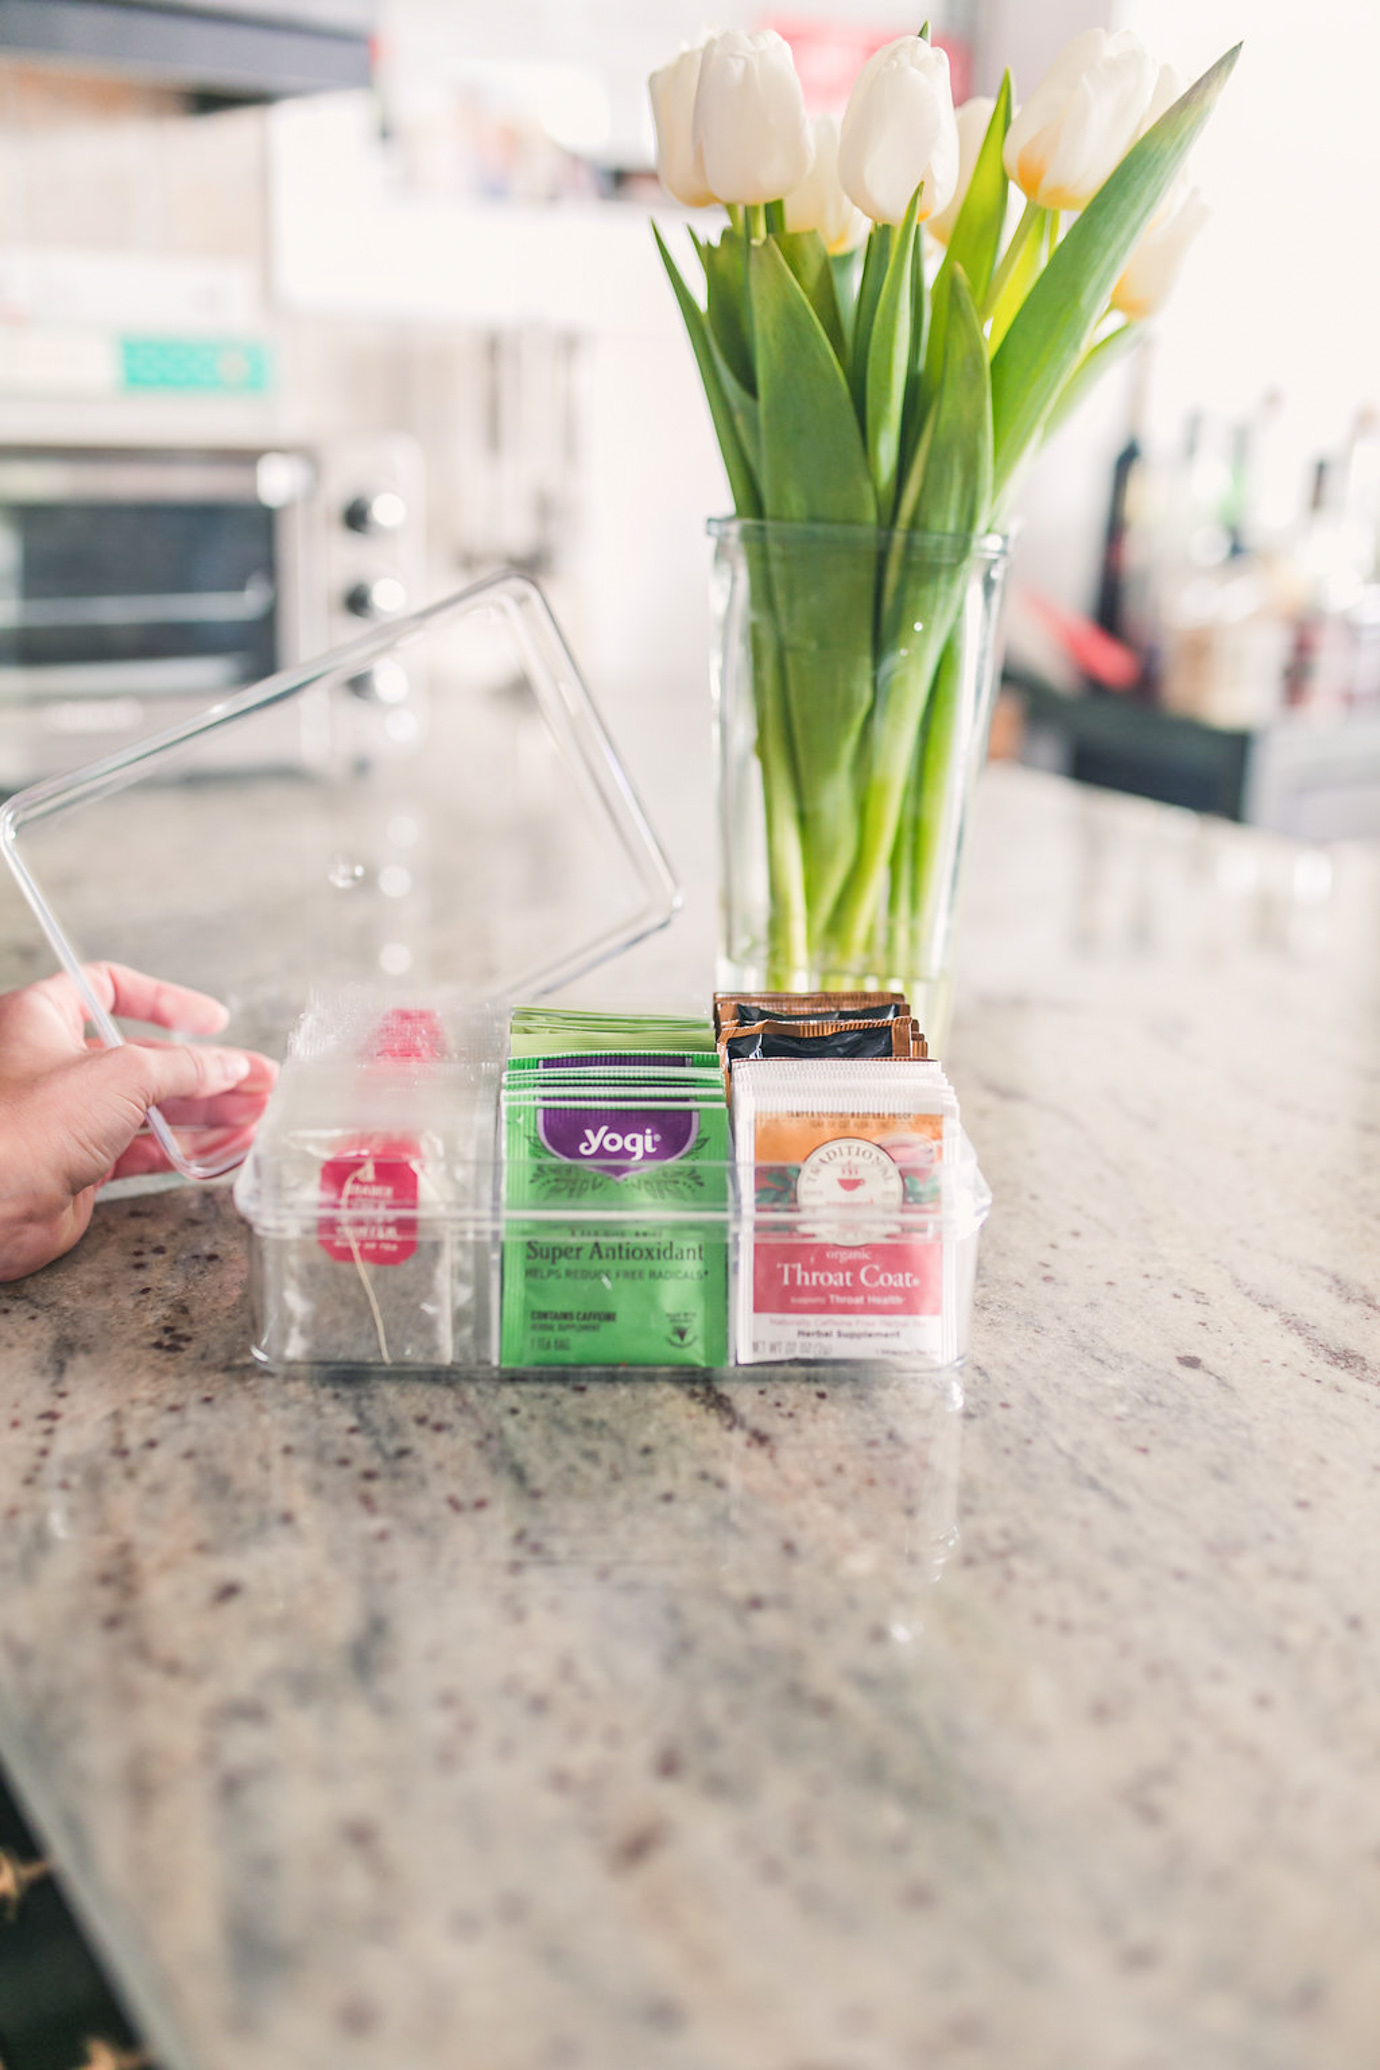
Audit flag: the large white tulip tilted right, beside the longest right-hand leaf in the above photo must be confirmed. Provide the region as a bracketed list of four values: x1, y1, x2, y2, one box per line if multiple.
[1001, 29, 1157, 209]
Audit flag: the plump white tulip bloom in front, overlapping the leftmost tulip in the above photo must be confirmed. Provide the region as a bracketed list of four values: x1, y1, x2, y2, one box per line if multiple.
[691, 29, 815, 203]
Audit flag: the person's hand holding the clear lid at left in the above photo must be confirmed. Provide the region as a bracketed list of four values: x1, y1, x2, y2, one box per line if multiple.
[0, 963, 277, 1281]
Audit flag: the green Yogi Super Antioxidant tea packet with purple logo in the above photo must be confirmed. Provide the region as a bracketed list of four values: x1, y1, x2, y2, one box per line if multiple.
[501, 1072, 728, 1366]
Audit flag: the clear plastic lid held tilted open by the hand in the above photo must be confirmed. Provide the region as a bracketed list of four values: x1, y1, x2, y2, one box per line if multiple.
[0, 573, 681, 1178]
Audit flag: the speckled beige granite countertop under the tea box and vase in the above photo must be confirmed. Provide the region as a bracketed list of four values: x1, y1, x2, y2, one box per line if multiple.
[0, 768, 1380, 2070]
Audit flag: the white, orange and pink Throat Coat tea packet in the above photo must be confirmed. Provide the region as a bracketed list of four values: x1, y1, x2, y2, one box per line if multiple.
[732, 1058, 958, 1364]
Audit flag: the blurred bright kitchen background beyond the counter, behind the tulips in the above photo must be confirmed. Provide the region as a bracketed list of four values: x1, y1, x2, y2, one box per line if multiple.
[0, 0, 1380, 931]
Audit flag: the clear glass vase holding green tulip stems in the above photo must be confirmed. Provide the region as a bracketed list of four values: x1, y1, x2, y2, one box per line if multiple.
[710, 520, 1008, 1052]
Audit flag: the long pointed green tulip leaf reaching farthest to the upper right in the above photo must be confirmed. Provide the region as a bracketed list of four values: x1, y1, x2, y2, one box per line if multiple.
[991, 43, 1241, 497]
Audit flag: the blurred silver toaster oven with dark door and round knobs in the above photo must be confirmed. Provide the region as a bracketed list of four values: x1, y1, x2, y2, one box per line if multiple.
[0, 437, 424, 791]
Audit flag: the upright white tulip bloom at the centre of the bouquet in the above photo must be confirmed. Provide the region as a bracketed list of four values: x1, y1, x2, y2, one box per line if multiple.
[838, 35, 958, 224]
